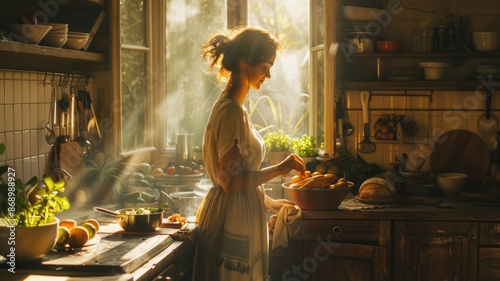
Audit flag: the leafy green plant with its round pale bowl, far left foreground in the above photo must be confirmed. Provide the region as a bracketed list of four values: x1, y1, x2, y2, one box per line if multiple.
[0, 144, 70, 262]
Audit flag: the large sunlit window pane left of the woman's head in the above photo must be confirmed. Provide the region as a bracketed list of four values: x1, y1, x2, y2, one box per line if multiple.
[165, 0, 226, 147]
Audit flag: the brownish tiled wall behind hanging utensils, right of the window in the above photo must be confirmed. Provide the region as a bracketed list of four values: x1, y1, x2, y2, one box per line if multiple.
[345, 88, 500, 170]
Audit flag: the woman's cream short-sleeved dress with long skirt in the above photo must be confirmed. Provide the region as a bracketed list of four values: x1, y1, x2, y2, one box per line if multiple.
[193, 96, 269, 281]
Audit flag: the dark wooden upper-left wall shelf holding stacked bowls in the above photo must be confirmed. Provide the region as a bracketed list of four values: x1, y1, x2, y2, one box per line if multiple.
[0, 0, 109, 73]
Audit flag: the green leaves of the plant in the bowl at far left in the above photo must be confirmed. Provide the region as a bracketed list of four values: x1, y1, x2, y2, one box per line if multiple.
[0, 143, 70, 227]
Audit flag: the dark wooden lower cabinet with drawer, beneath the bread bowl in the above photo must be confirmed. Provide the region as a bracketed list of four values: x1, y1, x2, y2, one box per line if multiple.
[271, 220, 391, 281]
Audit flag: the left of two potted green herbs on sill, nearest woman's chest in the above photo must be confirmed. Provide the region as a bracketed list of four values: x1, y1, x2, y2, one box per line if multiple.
[263, 130, 292, 165]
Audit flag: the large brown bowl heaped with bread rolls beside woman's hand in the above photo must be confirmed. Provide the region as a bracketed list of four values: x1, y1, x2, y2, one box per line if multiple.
[283, 173, 354, 211]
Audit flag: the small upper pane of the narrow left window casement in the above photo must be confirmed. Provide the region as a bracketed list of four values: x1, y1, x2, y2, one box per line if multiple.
[120, 0, 146, 46]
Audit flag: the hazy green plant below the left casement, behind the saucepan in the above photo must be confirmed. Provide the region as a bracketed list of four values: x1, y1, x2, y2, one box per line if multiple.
[74, 155, 124, 204]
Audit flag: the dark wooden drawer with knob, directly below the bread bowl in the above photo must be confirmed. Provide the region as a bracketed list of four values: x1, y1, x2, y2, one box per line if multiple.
[298, 220, 384, 242]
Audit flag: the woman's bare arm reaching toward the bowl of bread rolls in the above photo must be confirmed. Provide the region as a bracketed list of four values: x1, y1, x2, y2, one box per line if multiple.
[219, 144, 306, 193]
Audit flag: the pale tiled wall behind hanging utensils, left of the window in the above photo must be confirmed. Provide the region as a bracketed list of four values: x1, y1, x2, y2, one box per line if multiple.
[0, 69, 92, 181]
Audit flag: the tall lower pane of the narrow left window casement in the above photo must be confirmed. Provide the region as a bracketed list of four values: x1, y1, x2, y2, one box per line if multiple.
[120, 49, 147, 150]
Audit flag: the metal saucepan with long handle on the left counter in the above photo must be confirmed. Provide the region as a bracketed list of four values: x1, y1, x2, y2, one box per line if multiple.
[94, 207, 163, 232]
